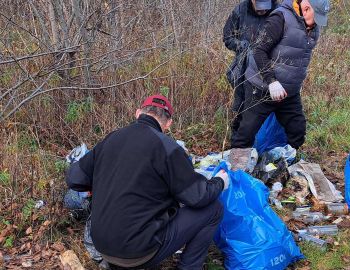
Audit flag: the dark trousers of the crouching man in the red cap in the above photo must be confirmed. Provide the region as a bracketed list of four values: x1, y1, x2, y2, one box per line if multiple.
[111, 201, 223, 270]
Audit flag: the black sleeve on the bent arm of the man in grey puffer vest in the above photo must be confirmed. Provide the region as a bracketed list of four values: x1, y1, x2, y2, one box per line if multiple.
[254, 12, 284, 84]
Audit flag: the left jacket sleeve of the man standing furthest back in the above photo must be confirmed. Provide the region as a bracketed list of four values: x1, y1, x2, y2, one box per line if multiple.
[223, 9, 240, 53]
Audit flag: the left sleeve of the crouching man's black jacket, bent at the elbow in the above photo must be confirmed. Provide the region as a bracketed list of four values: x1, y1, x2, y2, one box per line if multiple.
[66, 150, 94, 191]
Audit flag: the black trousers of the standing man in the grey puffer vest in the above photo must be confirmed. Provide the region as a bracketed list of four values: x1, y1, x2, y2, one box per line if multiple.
[231, 82, 306, 149]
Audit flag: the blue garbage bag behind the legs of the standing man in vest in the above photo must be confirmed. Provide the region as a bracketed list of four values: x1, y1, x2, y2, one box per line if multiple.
[254, 113, 288, 155]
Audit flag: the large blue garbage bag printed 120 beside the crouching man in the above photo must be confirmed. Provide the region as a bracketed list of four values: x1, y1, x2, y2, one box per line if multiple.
[214, 163, 304, 270]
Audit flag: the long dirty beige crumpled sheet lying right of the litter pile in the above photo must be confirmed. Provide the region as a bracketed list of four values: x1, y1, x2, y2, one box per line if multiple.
[288, 160, 344, 202]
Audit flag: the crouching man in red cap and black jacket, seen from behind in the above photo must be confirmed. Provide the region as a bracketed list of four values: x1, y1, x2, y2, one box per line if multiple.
[66, 95, 229, 270]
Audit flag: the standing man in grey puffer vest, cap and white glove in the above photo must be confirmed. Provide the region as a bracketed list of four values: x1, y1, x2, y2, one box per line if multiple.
[231, 0, 330, 149]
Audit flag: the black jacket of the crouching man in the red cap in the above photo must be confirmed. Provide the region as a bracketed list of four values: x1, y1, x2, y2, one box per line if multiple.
[66, 115, 224, 258]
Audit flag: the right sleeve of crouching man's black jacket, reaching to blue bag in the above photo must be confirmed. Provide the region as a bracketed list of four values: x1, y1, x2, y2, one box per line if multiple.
[165, 148, 224, 208]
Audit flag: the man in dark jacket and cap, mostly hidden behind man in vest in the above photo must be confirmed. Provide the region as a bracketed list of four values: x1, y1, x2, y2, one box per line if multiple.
[223, 0, 278, 146]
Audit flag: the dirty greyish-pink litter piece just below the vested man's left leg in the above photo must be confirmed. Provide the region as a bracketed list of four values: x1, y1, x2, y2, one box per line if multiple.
[229, 148, 258, 173]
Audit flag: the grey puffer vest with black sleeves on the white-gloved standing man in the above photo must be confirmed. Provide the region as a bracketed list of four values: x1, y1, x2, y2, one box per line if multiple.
[246, 0, 319, 96]
